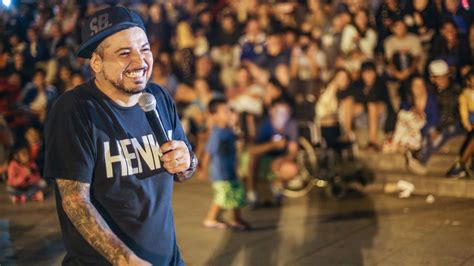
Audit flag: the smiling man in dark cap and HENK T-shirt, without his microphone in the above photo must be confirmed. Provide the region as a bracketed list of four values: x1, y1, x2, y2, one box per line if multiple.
[45, 7, 197, 265]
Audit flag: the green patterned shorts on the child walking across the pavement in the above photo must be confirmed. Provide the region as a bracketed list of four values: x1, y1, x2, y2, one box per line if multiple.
[212, 180, 245, 209]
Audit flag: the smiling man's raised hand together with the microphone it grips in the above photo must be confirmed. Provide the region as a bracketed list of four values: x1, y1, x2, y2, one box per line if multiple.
[138, 92, 191, 174]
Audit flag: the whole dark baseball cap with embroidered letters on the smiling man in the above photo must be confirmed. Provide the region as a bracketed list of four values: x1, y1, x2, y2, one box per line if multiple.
[77, 6, 146, 58]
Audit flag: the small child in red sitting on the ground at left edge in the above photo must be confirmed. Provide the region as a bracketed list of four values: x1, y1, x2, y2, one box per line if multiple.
[7, 145, 46, 203]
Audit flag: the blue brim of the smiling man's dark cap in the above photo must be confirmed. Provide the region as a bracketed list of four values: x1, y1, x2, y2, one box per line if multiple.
[76, 22, 143, 58]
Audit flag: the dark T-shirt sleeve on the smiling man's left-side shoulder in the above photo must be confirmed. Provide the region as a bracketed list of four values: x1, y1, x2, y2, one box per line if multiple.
[44, 93, 96, 183]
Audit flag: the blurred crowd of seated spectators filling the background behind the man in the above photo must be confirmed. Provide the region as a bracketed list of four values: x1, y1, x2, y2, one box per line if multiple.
[0, 0, 474, 210]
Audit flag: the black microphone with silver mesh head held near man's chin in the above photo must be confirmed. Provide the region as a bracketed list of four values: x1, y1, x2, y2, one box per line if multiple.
[138, 92, 170, 146]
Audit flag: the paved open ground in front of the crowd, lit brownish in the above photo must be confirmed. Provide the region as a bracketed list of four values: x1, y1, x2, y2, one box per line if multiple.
[0, 181, 474, 266]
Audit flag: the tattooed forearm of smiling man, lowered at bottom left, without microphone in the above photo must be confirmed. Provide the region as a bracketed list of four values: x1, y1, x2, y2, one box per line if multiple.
[56, 179, 133, 265]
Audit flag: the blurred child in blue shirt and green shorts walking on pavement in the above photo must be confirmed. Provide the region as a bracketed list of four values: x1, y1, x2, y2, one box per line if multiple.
[203, 99, 250, 230]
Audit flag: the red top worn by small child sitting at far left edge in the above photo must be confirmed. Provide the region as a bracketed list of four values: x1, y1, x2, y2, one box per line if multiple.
[7, 161, 41, 188]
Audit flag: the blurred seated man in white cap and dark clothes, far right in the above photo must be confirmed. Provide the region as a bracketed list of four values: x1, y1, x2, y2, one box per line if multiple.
[407, 59, 464, 175]
